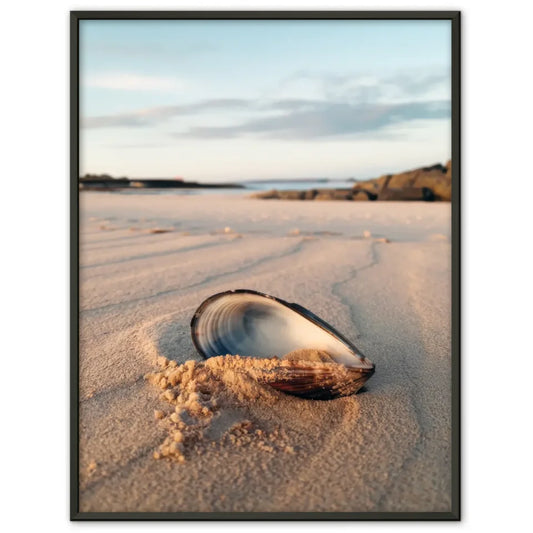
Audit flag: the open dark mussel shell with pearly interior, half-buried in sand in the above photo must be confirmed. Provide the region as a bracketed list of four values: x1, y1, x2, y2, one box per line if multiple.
[191, 289, 375, 399]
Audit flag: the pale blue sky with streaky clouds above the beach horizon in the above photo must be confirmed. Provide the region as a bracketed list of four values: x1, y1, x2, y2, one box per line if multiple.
[80, 20, 451, 181]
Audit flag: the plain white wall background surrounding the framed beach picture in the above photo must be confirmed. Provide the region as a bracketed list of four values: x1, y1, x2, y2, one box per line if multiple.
[0, 0, 533, 532]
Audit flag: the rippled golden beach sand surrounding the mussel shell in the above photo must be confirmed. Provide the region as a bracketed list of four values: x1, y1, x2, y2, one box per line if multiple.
[80, 192, 451, 512]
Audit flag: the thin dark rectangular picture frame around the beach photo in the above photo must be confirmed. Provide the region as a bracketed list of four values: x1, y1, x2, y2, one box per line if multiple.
[70, 11, 461, 520]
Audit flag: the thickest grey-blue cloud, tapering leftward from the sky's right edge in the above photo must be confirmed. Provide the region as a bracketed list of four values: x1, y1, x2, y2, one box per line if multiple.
[175, 101, 450, 139]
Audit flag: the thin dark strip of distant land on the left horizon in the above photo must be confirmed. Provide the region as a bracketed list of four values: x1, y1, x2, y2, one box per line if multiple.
[79, 174, 245, 191]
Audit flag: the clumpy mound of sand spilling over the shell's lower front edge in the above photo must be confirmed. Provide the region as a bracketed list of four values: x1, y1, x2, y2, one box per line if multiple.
[145, 350, 358, 462]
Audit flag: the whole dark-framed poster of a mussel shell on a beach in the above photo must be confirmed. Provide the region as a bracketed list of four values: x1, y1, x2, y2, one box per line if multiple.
[71, 11, 460, 520]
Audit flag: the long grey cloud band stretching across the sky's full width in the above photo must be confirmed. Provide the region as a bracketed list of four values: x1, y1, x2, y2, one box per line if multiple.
[82, 99, 451, 139]
